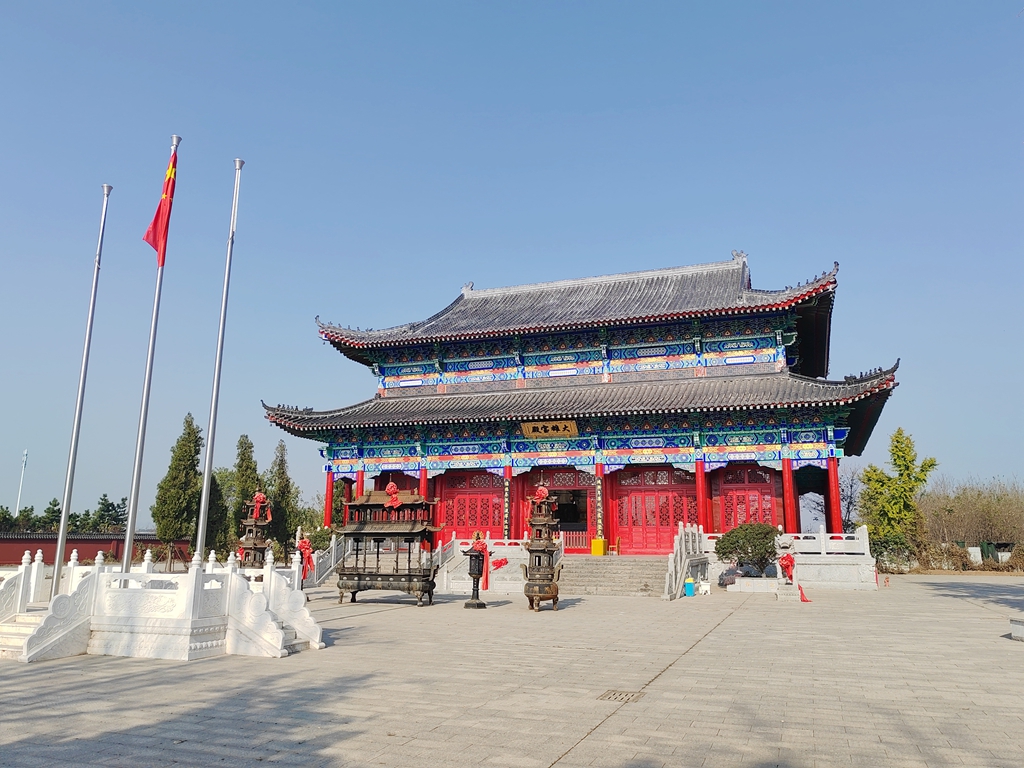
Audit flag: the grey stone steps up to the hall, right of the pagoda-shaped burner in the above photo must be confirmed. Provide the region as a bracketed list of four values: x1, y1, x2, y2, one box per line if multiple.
[558, 555, 669, 597]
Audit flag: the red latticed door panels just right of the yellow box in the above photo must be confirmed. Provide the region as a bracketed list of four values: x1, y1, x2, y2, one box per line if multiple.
[612, 467, 697, 555]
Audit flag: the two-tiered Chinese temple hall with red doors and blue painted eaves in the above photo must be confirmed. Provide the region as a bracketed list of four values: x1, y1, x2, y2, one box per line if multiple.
[264, 252, 896, 555]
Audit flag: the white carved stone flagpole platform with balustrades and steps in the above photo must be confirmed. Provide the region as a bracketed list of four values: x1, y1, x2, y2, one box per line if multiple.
[0, 551, 324, 662]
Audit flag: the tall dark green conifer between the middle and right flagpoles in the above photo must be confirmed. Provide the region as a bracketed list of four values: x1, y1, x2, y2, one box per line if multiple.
[150, 414, 203, 570]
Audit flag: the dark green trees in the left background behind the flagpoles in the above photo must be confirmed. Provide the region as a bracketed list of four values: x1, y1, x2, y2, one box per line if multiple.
[0, 414, 323, 559]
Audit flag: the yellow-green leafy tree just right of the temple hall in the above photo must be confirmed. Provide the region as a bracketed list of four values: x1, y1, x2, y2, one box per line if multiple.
[857, 427, 938, 557]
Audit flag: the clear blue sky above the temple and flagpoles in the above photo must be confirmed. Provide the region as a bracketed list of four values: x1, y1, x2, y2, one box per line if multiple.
[0, 0, 1024, 522]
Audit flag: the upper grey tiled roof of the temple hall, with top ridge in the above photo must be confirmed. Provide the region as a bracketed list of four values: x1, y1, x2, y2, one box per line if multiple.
[317, 252, 839, 348]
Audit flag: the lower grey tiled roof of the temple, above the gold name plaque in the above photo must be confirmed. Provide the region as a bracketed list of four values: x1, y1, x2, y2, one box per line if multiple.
[264, 364, 898, 437]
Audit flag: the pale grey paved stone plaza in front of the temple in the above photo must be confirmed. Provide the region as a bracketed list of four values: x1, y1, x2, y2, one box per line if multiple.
[0, 577, 1024, 768]
